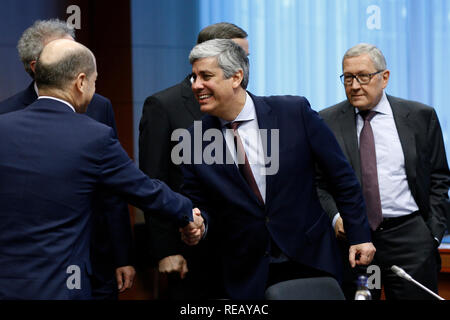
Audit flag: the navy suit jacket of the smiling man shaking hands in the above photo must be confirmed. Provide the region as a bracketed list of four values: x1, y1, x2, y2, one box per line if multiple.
[182, 95, 370, 299]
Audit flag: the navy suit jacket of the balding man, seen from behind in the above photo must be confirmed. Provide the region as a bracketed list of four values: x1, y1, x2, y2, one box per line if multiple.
[0, 99, 192, 299]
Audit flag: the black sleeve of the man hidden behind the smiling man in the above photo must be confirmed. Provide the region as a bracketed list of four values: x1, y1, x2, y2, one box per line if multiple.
[139, 96, 183, 261]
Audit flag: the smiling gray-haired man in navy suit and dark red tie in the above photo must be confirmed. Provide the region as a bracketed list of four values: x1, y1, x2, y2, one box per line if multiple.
[181, 39, 375, 299]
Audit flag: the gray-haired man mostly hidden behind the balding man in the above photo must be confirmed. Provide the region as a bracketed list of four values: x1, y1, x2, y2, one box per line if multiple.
[0, 19, 135, 299]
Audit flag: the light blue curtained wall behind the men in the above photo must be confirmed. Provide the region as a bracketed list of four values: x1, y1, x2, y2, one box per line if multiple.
[131, 0, 450, 164]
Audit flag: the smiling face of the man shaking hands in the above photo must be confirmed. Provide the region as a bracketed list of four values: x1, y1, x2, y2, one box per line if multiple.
[192, 57, 245, 119]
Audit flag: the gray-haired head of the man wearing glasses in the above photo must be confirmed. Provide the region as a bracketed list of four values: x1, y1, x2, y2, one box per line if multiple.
[342, 43, 390, 110]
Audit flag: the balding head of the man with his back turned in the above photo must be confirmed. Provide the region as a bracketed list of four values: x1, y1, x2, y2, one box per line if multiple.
[35, 39, 97, 112]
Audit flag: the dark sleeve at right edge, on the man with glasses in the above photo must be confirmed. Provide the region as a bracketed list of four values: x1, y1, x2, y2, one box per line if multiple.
[427, 109, 450, 241]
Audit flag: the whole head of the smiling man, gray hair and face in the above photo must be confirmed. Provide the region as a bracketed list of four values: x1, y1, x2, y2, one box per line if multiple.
[189, 39, 249, 119]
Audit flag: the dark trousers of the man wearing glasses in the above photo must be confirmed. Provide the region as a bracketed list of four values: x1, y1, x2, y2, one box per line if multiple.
[341, 213, 440, 300]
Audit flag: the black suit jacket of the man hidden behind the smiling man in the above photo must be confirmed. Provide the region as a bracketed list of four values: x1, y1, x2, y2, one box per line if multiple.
[139, 76, 202, 261]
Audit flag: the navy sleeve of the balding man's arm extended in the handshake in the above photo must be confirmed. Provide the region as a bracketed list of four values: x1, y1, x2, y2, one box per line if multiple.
[99, 129, 193, 227]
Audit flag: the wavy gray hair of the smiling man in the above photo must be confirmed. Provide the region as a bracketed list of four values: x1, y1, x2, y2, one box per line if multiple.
[189, 39, 249, 90]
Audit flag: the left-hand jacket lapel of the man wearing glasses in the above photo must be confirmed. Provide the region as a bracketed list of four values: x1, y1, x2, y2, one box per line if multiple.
[339, 103, 361, 183]
